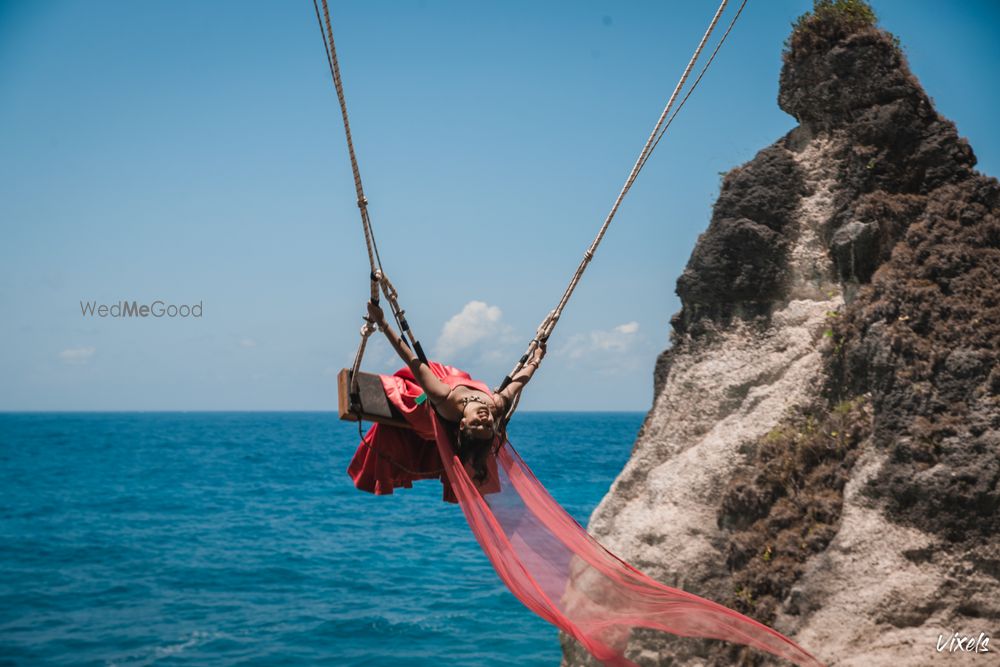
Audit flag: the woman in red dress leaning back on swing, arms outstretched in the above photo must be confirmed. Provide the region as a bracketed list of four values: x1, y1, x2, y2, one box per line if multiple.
[347, 302, 545, 502]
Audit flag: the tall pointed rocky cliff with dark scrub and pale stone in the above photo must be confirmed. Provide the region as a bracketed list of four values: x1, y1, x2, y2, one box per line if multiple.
[564, 0, 1000, 667]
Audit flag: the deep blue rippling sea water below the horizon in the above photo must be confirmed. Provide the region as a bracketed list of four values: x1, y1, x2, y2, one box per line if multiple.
[0, 413, 643, 667]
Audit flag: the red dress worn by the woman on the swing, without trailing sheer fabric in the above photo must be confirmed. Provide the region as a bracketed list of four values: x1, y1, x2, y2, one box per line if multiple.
[347, 361, 500, 503]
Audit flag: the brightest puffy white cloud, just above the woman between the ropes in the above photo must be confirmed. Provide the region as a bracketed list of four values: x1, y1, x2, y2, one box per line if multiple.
[434, 301, 515, 363]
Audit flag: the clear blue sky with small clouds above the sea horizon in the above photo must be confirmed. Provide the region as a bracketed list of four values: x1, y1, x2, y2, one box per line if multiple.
[0, 0, 1000, 410]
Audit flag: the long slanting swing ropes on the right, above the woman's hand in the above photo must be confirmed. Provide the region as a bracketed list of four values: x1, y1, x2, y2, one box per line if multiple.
[497, 0, 747, 400]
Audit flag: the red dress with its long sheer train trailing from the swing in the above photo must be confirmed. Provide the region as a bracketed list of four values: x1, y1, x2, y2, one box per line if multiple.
[348, 362, 822, 667]
